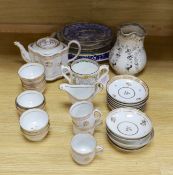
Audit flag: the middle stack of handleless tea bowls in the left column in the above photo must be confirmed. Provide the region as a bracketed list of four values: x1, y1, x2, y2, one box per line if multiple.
[15, 90, 45, 115]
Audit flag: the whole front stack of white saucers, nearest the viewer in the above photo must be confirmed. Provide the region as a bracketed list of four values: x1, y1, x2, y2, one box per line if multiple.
[106, 108, 154, 151]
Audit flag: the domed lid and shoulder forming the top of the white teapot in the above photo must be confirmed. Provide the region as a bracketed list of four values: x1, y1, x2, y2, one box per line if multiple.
[31, 37, 65, 55]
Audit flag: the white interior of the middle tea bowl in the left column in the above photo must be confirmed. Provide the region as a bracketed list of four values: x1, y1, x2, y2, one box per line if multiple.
[16, 90, 44, 108]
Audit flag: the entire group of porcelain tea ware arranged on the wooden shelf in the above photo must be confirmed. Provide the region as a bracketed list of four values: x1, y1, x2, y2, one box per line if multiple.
[14, 23, 154, 165]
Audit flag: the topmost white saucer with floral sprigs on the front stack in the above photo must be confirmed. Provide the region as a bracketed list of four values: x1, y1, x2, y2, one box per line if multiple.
[106, 108, 152, 139]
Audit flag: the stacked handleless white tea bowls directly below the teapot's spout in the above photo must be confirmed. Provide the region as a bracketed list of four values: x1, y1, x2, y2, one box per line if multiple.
[18, 63, 46, 92]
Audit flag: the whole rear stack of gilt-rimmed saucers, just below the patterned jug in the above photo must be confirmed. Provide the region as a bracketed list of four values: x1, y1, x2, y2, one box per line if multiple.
[107, 75, 149, 111]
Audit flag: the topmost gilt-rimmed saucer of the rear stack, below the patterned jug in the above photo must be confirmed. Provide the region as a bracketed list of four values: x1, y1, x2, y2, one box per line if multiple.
[107, 75, 149, 104]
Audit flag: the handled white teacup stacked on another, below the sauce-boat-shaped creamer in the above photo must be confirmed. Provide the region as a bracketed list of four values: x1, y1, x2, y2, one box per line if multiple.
[69, 101, 102, 129]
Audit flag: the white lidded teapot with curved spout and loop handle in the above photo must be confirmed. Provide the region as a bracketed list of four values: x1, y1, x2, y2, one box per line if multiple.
[14, 37, 81, 81]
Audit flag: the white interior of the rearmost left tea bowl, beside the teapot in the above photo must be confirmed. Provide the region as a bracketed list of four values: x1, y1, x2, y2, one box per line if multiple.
[18, 63, 44, 79]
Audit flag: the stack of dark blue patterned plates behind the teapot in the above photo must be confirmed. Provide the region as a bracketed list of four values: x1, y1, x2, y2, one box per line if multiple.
[55, 23, 113, 61]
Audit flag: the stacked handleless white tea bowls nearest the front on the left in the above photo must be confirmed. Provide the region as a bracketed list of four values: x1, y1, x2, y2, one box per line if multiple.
[19, 108, 49, 141]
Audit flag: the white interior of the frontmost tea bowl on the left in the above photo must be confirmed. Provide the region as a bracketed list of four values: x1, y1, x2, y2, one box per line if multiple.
[20, 109, 49, 132]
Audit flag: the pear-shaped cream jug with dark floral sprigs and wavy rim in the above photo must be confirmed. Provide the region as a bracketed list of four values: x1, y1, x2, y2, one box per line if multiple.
[109, 24, 147, 75]
